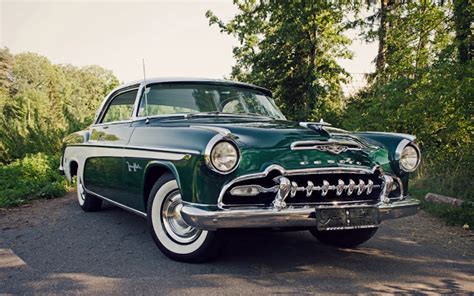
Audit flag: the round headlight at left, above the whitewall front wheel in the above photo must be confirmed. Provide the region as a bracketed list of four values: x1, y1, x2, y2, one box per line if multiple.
[209, 141, 239, 174]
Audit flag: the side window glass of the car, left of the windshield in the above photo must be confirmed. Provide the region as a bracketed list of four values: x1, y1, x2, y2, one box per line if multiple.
[101, 89, 138, 123]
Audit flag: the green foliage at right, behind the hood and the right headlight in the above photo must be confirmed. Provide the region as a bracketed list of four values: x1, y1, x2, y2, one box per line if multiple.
[342, 2, 474, 201]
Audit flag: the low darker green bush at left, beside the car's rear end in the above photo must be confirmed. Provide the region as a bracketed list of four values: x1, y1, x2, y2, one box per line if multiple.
[0, 153, 69, 207]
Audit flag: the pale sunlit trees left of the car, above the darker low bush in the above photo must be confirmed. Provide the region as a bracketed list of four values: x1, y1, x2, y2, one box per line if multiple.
[0, 49, 118, 163]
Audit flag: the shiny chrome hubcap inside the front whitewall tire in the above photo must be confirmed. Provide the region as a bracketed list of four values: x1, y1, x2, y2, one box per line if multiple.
[161, 191, 201, 244]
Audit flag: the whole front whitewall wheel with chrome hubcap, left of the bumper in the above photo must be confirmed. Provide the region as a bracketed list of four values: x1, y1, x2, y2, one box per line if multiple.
[147, 174, 218, 262]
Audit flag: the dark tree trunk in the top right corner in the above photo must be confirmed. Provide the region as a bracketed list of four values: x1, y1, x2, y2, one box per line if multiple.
[454, 0, 474, 64]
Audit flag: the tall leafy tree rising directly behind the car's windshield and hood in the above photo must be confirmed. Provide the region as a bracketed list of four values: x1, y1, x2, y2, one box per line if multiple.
[206, 0, 351, 120]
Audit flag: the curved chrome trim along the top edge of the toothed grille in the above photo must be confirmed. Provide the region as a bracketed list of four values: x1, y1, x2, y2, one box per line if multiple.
[217, 164, 380, 210]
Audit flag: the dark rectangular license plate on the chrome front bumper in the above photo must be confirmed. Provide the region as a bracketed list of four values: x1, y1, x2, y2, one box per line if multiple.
[316, 207, 380, 230]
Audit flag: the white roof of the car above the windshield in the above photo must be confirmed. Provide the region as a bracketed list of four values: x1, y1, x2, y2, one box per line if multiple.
[116, 77, 272, 97]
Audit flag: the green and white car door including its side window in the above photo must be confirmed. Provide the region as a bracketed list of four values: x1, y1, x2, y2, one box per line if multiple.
[84, 87, 138, 205]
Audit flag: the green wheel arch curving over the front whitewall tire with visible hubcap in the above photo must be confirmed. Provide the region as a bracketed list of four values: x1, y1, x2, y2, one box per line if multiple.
[143, 161, 181, 210]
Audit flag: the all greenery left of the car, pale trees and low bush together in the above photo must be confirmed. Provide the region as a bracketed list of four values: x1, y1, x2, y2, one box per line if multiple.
[0, 49, 118, 207]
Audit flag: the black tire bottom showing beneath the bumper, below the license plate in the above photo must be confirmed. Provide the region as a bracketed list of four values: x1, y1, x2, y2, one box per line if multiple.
[310, 228, 378, 248]
